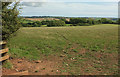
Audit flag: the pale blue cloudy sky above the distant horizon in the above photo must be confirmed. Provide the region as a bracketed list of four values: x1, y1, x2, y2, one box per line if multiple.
[21, 0, 118, 17]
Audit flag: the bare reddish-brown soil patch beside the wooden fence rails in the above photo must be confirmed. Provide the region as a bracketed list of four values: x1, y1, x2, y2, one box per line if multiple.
[2, 58, 68, 75]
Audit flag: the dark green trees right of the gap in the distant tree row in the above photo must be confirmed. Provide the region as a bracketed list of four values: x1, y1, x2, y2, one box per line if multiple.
[70, 18, 116, 26]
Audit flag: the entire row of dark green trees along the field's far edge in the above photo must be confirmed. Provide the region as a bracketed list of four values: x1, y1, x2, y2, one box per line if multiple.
[21, 18, 118, 27]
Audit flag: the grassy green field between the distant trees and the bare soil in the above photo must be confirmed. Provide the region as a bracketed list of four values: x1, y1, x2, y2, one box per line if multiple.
[8, 24, 118, 75]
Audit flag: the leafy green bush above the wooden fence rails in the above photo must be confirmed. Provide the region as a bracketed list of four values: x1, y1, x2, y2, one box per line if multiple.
[2, 2, 20, 40]
